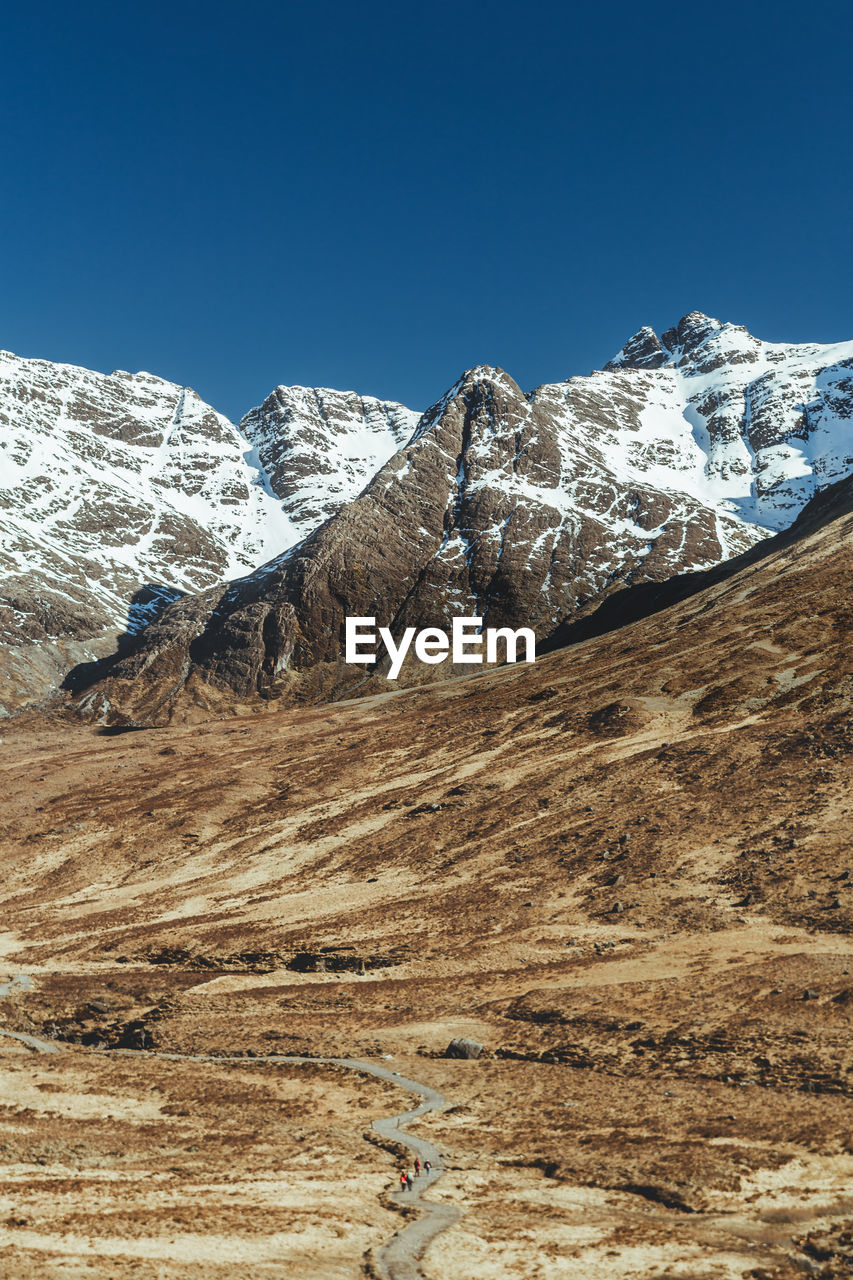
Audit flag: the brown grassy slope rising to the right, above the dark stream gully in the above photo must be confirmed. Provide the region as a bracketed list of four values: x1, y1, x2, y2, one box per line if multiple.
[1, 476, 853, 964]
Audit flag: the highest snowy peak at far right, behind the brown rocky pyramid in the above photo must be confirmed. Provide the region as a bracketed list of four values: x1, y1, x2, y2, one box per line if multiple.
[596, 311, 853, 530]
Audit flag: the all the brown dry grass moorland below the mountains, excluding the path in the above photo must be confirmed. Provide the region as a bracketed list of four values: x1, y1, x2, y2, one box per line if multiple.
[0, 481, 853, 1280]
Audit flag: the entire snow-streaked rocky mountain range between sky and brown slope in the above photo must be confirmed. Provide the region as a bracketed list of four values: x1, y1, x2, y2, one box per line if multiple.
[0, 312, 853, 718]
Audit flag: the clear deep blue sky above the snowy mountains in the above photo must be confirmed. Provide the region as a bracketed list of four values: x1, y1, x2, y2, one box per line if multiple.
[0, 0, 853, 417]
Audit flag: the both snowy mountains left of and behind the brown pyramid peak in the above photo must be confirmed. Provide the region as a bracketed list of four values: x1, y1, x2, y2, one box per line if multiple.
[0, 352, 418, 714]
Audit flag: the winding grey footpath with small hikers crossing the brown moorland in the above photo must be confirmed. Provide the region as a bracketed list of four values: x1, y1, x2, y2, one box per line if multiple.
[0, 974, 461, 1280]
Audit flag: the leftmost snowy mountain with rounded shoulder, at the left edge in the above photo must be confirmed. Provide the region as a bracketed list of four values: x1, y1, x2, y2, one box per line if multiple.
[0, 355, 295, 639]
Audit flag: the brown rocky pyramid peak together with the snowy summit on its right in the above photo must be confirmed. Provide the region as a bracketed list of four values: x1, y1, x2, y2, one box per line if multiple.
[81, 312, 853, 722]
